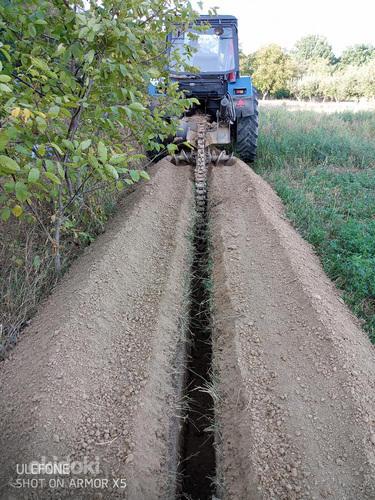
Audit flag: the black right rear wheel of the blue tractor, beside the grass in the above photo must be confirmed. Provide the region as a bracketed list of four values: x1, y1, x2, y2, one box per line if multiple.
[236, 87, 258, 163]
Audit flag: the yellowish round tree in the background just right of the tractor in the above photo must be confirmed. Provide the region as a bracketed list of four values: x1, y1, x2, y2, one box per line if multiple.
[253, 44, 298, 99]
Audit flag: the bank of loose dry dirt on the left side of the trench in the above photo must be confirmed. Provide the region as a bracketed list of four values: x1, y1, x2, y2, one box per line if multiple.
[0, 160, 194, 500]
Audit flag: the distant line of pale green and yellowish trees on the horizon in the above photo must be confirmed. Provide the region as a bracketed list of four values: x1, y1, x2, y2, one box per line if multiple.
[240, 35, 375, 101]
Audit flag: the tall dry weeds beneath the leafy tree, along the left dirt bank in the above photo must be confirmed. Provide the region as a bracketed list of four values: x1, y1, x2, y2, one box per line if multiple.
[0, 188, 119, 360]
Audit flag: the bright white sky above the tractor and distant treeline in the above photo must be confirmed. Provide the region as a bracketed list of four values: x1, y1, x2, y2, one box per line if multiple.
[192, 0, 375, 57]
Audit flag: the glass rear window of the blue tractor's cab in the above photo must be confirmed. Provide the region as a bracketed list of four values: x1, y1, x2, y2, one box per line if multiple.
[172, 28, 235, 73]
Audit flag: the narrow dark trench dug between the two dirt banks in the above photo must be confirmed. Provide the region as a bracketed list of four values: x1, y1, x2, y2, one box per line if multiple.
[177, 187, 216, 500]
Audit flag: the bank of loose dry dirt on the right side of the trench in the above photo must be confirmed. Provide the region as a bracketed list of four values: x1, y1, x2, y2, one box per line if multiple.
[210, 161, 375, 500]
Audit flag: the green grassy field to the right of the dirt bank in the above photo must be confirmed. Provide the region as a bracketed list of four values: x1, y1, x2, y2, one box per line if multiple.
[254, 107, 375, 343]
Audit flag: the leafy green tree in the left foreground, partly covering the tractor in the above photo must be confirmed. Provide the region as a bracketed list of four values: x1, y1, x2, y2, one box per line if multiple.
[0, 0, 204, 270]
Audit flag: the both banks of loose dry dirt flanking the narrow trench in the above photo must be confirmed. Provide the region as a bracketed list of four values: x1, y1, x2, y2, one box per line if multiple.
[0, 160, 375, 500]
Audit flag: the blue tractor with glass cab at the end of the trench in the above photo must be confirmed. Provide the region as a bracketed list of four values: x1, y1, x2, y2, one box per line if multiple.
[149, 15, 258, 163]
